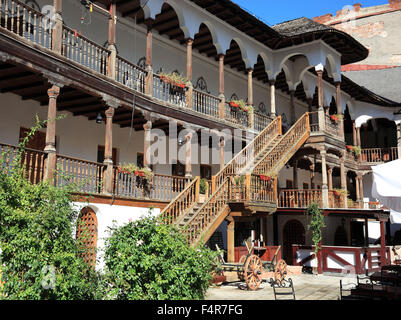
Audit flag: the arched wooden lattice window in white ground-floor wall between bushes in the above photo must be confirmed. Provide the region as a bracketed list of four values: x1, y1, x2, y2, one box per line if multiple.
[77, 207, 97, 266]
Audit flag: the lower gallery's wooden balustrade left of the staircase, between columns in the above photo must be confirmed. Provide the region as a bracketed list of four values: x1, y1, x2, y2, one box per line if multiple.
[0, 144, 188, 202]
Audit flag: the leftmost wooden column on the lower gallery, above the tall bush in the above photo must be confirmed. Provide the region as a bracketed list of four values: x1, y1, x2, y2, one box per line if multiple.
[44, 84, 60, 184]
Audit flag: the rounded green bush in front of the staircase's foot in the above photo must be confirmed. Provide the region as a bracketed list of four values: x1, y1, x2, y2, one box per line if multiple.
[101, 215, 216, 300]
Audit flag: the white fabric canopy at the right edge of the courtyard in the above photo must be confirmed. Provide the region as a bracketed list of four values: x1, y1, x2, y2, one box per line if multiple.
[372, 160, 401, 223]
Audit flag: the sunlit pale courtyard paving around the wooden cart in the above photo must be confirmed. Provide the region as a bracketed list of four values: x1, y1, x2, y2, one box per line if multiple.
[206, 274, 356, 300]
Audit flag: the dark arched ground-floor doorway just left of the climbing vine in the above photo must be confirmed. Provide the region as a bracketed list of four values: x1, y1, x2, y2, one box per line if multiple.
[283, 220, 305, 265]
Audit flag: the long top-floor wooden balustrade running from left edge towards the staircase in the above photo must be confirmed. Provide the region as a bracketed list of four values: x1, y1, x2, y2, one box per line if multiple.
[0, 0, 270, 131]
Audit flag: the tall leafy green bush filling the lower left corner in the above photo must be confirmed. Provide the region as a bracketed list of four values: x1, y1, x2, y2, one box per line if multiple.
[0, 122, 100, 300]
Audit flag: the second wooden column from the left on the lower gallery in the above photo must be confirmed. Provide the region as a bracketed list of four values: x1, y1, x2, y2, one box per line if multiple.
[103, 107, 115, 194]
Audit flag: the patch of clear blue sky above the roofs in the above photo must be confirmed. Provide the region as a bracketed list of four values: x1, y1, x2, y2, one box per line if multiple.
[232, 0, 388, 25]
